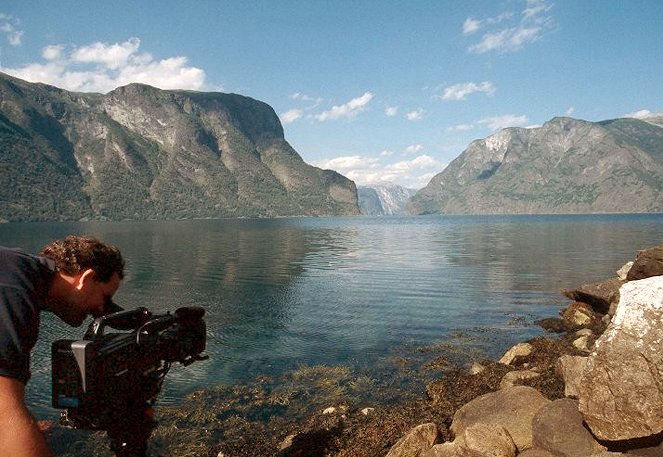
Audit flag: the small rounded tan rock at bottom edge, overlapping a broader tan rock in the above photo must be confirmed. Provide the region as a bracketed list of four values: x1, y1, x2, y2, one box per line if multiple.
[456, 422, 516, 457]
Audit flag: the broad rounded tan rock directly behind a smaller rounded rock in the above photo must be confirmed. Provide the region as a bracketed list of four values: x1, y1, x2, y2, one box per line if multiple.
[450, 386, 550, 451]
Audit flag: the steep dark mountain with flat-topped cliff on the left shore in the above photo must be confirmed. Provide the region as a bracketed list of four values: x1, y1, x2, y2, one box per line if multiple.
[0, 73, 359, 221]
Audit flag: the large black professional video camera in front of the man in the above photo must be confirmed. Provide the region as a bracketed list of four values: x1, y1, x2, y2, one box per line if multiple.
[51, 307, 206, 430]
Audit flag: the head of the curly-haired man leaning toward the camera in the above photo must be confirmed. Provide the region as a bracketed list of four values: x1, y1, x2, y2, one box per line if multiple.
[39, 236, 124, 326]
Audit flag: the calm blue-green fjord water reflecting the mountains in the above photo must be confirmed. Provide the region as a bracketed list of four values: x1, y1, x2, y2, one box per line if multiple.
[0, 214, 663, 416]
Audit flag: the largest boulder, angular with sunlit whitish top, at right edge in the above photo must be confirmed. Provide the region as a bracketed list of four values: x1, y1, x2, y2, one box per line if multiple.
[578, 276, 663, 440]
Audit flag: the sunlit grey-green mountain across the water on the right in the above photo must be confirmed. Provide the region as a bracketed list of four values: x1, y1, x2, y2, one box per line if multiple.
[406, 114, 663, 214]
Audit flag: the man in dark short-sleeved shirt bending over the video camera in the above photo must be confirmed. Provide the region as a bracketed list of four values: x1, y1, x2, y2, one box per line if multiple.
[0, 236, 124, 457]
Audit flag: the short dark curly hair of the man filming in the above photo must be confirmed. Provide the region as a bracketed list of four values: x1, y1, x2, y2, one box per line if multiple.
[39, 235, 124, 282]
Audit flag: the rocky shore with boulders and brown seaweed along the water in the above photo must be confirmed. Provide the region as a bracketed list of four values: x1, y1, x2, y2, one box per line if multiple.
[49, 245, 663, 457]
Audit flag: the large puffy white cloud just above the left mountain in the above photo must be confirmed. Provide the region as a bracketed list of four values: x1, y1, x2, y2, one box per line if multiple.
[2, 38, 205, 93]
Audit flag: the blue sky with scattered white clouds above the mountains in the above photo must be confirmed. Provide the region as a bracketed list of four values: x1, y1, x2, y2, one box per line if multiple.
[0, 0, 663, 188]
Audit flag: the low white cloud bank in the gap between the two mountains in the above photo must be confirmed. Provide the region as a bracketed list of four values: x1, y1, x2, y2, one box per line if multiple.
[313, 153, 446, 189]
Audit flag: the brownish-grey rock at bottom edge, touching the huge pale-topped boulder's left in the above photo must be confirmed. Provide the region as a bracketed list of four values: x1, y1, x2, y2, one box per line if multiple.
[532, 398, 606, 457]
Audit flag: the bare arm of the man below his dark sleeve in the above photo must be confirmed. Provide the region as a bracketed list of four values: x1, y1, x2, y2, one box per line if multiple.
[0, 376, 53, 457]
